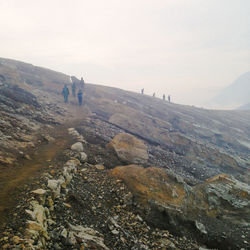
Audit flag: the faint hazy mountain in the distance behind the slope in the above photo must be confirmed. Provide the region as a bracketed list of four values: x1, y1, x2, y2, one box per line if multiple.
[208, 72, 250, 109]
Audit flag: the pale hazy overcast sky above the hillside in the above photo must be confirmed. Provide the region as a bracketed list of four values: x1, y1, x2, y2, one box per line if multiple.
[0, 0, 250, 105]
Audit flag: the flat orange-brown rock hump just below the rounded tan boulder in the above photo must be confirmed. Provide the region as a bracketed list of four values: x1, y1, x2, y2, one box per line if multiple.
[110, 165, 186, 205]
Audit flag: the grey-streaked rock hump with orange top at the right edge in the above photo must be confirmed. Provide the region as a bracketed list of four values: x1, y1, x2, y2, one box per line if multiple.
[193, 174, 250, 226]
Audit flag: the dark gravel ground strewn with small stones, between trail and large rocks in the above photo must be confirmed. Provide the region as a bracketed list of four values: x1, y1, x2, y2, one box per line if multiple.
[0, 123, 199, 249]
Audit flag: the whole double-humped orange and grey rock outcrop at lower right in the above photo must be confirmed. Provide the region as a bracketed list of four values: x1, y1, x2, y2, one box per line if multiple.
[110, 165, 250, 249]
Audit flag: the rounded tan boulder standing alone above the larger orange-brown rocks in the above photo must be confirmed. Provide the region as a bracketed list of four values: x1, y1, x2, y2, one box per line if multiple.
[108, 133, 148, 163]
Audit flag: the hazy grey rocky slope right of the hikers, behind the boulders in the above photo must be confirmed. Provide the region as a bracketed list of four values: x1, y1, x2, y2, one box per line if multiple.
[85, 85, 250, 183]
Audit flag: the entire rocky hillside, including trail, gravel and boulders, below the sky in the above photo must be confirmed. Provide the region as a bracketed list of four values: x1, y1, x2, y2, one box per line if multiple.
[0, 59, 250, 249]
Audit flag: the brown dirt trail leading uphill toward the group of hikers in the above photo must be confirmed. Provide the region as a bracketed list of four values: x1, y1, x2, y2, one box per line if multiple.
[0, 102, 87, 228]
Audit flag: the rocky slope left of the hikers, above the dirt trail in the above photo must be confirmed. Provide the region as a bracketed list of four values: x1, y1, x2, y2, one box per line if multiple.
[0, 58, 73, 165]
